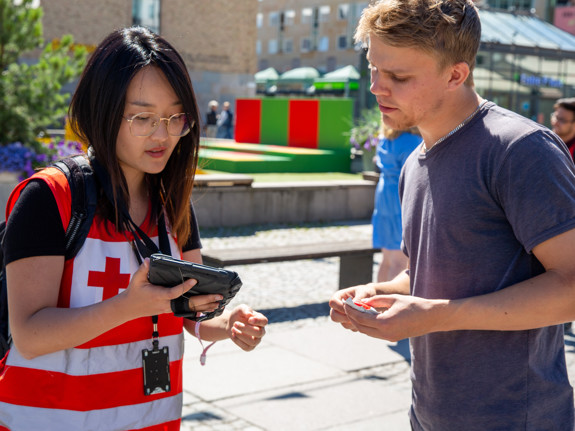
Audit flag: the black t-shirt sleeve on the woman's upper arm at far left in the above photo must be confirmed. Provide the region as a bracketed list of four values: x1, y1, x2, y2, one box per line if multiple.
[4, 180, 66, 264]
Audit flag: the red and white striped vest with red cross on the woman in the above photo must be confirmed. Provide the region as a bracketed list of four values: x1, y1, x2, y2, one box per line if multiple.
[0, 168, 184, 431]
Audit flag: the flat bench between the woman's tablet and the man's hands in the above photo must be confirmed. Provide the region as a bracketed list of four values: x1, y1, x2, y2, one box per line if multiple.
[202, 240, 380, 289]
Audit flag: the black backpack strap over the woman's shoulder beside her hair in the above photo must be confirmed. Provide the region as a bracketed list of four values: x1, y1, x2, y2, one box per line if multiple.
[54, 154, 98, 260]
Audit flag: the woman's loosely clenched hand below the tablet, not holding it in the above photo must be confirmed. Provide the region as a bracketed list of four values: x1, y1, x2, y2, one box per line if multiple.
[226, 304, 268, 352]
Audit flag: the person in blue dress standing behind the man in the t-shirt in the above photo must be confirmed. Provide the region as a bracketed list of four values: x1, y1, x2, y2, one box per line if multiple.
[371, 124, 421, 281]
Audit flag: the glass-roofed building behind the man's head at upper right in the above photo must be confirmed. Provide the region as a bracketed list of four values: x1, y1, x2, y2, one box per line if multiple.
[473, 10, 575, 126]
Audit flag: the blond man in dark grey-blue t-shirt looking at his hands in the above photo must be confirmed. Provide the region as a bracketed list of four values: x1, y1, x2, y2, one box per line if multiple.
[330, 0, 575, 431]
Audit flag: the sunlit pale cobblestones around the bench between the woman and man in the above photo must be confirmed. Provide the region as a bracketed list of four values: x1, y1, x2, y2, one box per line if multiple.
[201, 221, 380, 325]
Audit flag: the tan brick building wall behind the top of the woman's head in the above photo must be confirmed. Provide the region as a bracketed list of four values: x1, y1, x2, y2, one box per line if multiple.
[42, 0, 258, 119]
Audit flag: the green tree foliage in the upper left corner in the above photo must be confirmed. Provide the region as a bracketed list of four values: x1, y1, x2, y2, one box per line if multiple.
[0, 0, 87, 149]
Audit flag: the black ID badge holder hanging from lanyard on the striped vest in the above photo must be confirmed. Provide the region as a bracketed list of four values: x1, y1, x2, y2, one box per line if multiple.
[142, 316, 170, 395]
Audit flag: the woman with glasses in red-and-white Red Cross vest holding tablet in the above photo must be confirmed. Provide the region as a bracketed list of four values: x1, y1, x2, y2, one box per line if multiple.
[0, 27, 267, 430]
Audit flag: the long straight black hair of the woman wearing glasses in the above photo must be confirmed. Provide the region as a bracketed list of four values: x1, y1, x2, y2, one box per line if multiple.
[69, 27, 200, 244]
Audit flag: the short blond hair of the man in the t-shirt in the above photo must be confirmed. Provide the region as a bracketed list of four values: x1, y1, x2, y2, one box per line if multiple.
[355, 0, 481, 86]
